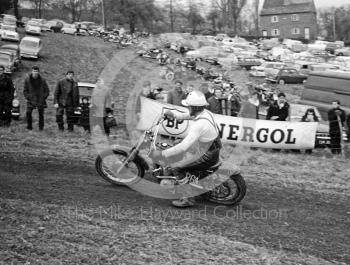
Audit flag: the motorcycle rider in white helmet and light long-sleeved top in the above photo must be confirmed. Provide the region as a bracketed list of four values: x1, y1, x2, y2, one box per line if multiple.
[152, 90, 222, 207]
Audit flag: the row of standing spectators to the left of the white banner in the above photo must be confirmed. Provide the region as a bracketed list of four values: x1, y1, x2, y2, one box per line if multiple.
[0, 66, 116, 135]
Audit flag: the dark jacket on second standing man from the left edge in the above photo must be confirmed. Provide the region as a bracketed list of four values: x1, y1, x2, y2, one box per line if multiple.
[23, 74, 50, 108]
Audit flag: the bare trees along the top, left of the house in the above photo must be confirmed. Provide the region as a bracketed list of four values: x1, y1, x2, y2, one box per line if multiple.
[0, 0, 259, 34]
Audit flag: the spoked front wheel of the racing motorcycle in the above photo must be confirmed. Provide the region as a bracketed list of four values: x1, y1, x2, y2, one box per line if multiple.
[95, 150, 145, 186]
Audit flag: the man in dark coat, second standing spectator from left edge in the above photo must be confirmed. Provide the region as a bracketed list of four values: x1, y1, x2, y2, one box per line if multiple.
[23, 66, 50, 131]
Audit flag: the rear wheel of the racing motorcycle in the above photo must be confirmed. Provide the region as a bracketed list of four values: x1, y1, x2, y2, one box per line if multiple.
[205, 174, 247, 205]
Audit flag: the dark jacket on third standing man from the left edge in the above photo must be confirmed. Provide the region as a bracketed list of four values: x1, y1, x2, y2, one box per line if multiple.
[54, 78, 79, 108]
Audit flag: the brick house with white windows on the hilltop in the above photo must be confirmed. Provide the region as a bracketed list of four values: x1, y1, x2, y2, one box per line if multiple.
[260, 0, 317, 40]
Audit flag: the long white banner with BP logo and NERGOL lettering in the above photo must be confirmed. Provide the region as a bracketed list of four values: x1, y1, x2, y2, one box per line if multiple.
[137, 97, 317, 149]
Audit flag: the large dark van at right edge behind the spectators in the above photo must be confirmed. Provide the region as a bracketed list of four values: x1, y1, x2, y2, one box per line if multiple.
[300, 71, 350, 120]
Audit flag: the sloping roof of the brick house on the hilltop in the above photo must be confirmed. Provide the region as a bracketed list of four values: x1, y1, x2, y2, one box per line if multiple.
[260, 0, 316, 16]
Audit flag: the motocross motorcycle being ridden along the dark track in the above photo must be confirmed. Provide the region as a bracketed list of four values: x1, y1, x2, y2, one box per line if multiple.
[95, 117, 246, 206]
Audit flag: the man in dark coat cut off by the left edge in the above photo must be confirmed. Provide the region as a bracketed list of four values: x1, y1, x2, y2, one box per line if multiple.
[0, 66, 15, 126]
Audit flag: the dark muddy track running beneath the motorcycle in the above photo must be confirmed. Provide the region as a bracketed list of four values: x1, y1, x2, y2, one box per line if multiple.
[0, 156, 350, 264]
